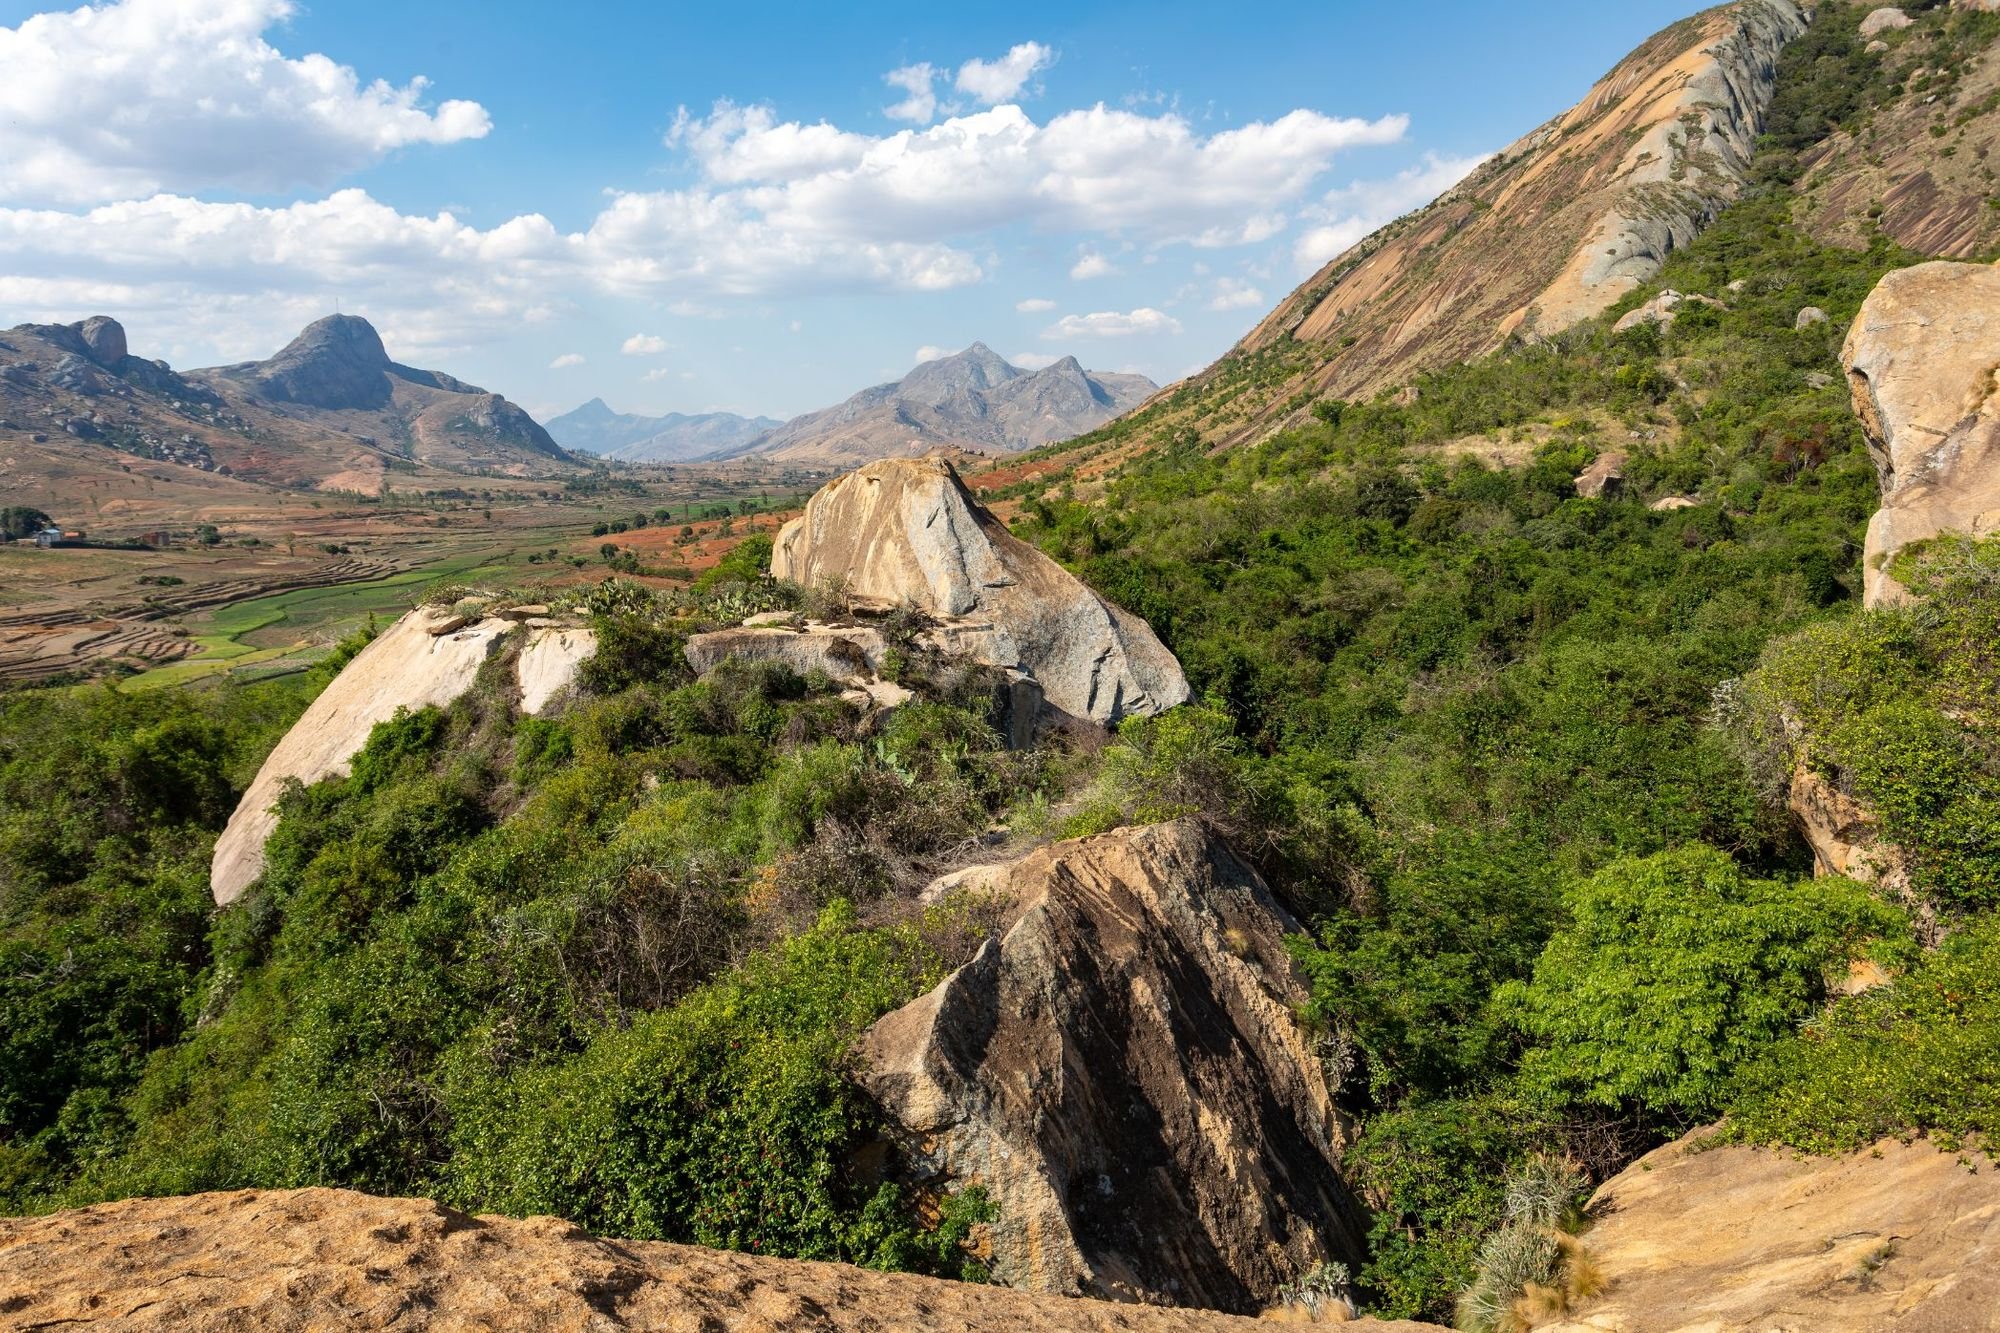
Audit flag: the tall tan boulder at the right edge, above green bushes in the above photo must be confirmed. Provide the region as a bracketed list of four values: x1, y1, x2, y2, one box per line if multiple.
[1840, 262, 2000, 606]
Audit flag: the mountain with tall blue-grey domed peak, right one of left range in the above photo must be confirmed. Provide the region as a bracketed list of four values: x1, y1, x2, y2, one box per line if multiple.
[190, 314, 570, 476]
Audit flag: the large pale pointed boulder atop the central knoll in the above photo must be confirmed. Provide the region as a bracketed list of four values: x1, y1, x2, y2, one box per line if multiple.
[770, 458, 1188, 723]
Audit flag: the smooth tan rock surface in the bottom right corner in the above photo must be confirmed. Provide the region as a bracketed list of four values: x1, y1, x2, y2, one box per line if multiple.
[1552, 1131, 2000, 1333]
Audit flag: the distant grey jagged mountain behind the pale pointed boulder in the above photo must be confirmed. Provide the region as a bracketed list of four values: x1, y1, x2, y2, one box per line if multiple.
[716, 342, 1158, 464]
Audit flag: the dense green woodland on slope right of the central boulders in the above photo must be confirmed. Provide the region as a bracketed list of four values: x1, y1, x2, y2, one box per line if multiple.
[1000, 150, 1994, 1315]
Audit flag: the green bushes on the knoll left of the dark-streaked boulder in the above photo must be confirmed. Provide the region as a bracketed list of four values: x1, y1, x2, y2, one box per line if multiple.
[0, 584, 1060, 1273]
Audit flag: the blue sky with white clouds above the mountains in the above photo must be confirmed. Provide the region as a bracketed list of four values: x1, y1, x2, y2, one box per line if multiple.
[0, 0, 1690, 416]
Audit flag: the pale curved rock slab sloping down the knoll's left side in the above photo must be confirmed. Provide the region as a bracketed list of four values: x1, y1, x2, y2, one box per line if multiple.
[208, 606, 596, 903]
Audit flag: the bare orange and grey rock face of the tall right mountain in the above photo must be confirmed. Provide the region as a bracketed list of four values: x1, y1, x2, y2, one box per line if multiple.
[1168, 0, 1806, 440]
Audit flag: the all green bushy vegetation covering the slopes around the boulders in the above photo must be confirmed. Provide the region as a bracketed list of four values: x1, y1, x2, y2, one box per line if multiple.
[0, 4, 2000, 1327]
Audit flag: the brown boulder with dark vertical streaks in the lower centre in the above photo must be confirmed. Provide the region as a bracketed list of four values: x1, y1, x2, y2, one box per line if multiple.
[860, 821, 1368, 1311]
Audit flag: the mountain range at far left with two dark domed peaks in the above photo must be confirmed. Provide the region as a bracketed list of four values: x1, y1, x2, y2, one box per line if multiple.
[0, 314, 576, 496]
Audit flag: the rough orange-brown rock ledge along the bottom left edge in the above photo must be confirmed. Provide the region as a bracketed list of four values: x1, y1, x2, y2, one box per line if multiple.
[0, 1189, 1432, 1333]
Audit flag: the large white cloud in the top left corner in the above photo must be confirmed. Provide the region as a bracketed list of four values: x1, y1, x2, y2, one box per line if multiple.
[0, 0, 492, 204]
